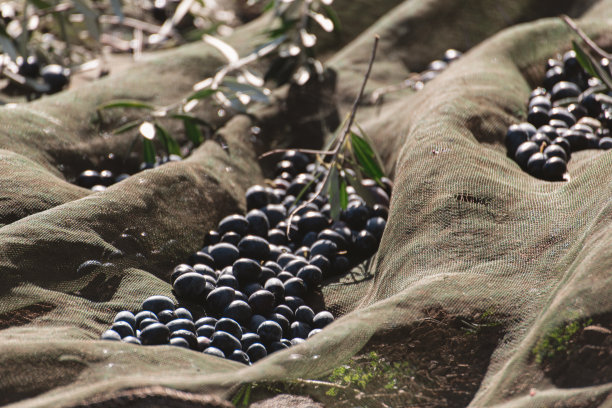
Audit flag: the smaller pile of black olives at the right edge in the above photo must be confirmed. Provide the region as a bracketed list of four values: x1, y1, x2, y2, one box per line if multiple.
[506, 50, 612, 181]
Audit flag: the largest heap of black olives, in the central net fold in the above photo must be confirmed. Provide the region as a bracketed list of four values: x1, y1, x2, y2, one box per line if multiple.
[101, 151, 391, 364]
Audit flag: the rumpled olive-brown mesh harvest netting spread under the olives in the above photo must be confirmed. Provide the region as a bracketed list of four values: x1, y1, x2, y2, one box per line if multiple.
[0, 0, 612, 407]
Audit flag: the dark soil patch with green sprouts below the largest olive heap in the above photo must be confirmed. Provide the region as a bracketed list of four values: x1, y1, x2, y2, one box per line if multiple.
[244, 309, 505, 408]
